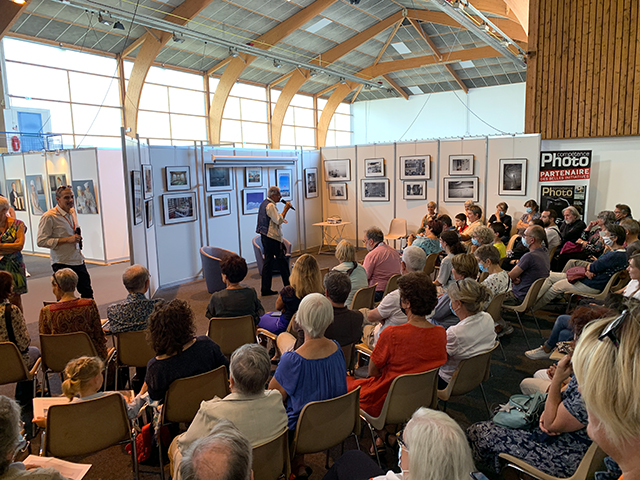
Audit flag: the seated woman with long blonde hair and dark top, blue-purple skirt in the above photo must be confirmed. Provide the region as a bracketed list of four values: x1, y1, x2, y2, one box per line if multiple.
[258, 253, 323, 334]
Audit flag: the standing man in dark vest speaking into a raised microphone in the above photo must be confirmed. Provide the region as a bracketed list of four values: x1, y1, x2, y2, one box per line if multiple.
[256, 187, 295, 297]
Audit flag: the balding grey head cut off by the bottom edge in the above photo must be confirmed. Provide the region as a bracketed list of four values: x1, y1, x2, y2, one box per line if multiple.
[178, 420, 253, 480]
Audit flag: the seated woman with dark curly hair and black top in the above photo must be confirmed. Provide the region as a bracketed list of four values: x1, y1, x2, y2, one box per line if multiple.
[141, 299, 229, 402]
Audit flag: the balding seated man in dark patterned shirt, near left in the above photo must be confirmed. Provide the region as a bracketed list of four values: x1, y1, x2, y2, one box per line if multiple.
[105, 265, 162, 333]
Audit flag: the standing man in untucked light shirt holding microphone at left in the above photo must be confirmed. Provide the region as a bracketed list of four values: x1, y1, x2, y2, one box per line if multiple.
[37, 185, 93, 298]
